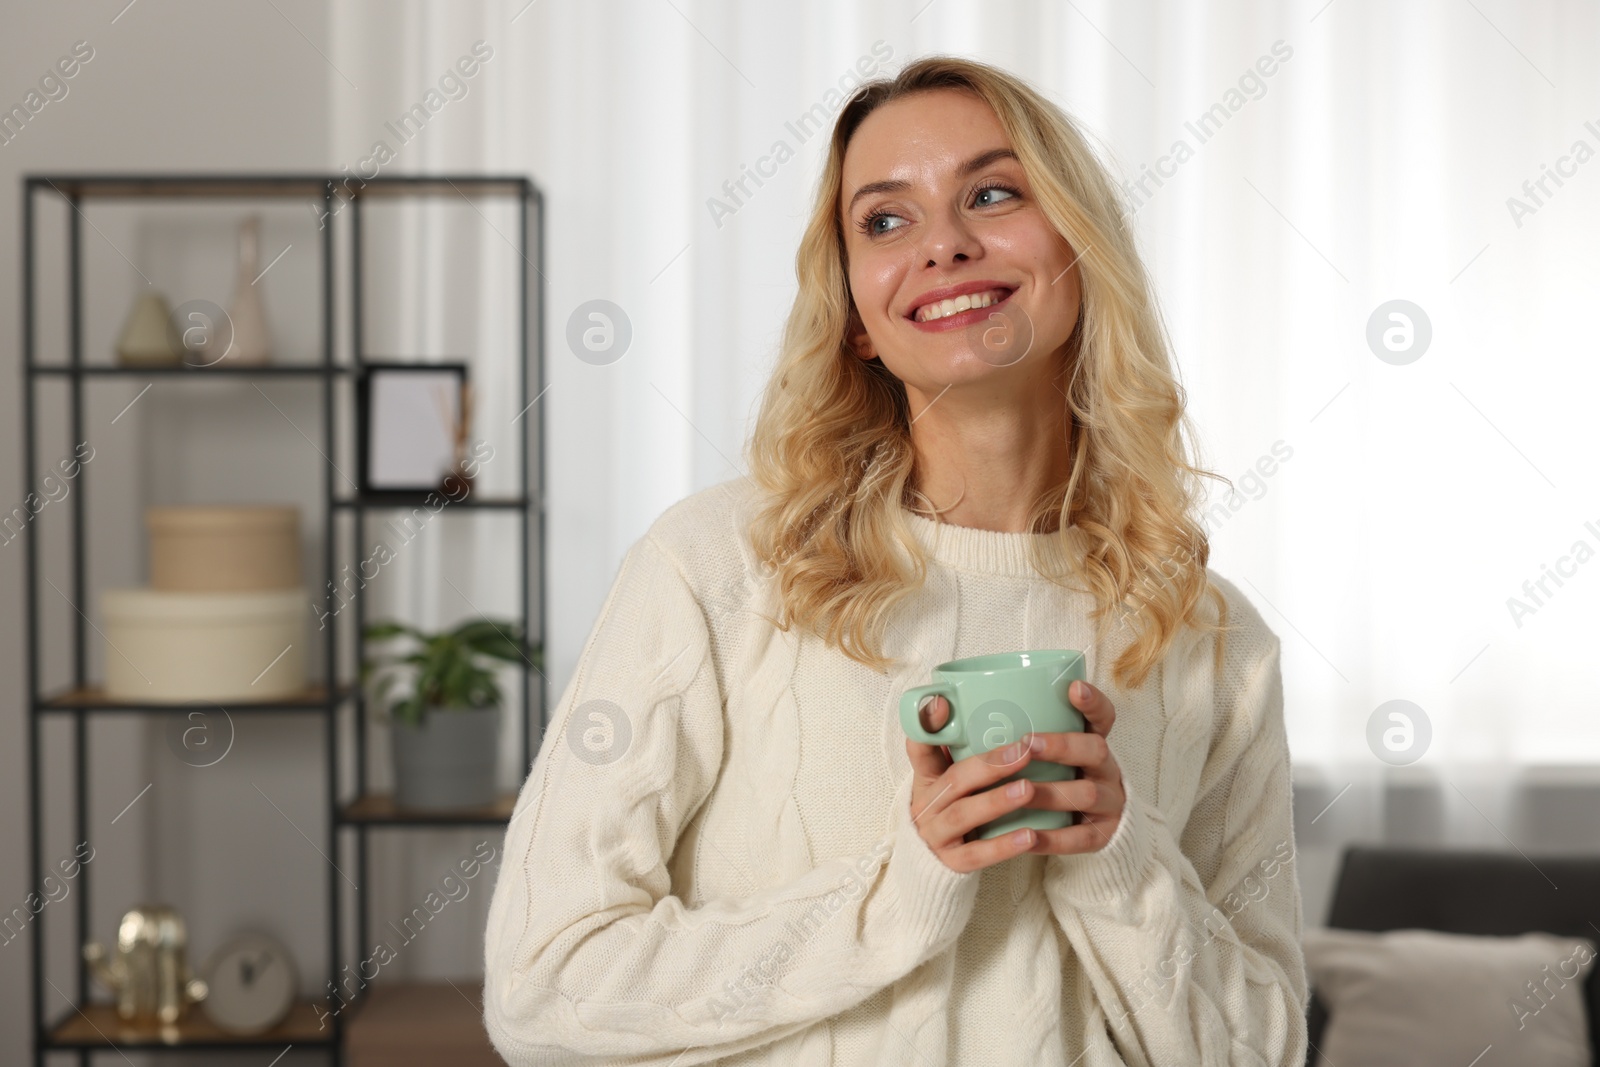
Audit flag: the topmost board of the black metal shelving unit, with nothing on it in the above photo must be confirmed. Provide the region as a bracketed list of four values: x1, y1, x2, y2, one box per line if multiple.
[26, 174, 539, 200]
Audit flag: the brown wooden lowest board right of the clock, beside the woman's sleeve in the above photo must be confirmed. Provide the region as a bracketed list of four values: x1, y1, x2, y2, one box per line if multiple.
[344, 982, 506, 1067]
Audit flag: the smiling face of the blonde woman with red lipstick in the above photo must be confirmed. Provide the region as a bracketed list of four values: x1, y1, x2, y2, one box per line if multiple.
[838, 90, 1080, 404]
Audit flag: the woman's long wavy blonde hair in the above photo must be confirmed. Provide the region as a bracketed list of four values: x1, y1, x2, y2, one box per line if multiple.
[746, 56, 1232, 688]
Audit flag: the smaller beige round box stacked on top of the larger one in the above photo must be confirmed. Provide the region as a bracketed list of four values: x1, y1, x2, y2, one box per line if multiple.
[144, 504, 302, 593]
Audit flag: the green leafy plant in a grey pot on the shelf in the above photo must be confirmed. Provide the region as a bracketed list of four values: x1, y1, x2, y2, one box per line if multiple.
[362, 617, 542, 809]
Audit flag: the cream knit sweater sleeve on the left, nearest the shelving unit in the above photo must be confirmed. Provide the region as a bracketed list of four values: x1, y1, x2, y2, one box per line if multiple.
[485, 534, 978, 1067]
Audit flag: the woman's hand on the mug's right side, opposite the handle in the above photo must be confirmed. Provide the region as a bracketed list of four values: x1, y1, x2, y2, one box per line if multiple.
[1017, 681, 1128, 856]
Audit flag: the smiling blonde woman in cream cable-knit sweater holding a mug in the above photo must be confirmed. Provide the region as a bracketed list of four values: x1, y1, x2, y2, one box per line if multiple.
[485, 56, 1307, 1067]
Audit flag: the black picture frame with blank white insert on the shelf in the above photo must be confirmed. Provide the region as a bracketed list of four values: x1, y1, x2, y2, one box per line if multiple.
[355, 362, 467, 499]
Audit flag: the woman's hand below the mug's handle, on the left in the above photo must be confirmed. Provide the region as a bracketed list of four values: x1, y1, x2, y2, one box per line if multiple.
[906, 694, 1043, 873]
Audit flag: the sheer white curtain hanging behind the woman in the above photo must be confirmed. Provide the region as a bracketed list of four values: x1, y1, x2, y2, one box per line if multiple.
[328, 0, 1600, 953]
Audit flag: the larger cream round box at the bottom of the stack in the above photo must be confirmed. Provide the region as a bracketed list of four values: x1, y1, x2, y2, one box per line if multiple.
[101, 587, 310, 702]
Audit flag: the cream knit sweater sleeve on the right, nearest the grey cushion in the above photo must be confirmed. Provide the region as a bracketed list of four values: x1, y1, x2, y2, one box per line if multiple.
[1045, 625, 1309, 1067]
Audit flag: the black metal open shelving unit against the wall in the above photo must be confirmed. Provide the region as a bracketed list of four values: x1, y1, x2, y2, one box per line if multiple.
[22, 174, 550, 1067]
